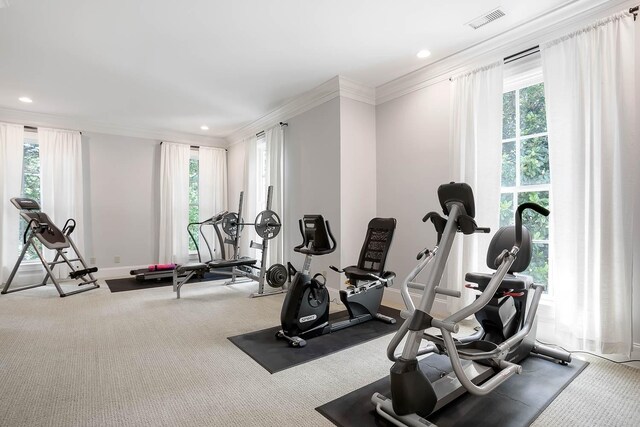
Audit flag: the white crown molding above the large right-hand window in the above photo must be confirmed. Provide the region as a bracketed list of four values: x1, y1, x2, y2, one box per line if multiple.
[376, 0, 637, 105]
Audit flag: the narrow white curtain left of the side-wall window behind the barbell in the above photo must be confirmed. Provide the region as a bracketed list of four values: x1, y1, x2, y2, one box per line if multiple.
[240, 136, 258, 258]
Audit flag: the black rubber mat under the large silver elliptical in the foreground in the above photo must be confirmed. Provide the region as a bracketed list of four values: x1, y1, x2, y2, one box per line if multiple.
[316, 355, 588, 427]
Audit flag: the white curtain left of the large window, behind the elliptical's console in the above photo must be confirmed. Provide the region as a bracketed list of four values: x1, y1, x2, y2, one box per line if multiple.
[446, 62, 503, 312]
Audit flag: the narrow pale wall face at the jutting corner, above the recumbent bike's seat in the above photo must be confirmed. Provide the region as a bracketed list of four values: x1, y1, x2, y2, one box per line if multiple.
[339, 97, 377, 267]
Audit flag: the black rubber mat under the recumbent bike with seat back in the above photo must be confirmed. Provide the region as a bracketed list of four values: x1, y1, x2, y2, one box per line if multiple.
[228, 306, 402, 374]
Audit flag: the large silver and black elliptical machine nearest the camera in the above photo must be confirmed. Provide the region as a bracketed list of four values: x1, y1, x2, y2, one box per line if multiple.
[371, 183, 571, 427]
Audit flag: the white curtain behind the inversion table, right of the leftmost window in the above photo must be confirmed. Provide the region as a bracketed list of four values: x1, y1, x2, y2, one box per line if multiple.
[38, 128, 84, 277]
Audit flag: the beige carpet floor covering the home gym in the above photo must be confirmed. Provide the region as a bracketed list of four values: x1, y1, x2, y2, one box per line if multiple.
[0, 282, 640, 427]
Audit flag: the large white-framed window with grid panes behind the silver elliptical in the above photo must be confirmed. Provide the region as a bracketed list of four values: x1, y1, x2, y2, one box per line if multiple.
[500, 81, 551, 292]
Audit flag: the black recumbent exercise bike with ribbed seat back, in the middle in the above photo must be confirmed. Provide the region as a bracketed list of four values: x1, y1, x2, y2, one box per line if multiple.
[276, 215, 396, 347]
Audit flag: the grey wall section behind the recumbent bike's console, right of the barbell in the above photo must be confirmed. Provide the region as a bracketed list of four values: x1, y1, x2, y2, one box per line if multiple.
[283, 98, 341, 282]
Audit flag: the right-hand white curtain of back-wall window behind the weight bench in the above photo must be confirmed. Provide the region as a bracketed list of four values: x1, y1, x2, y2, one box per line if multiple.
[200, 147, 227, 261]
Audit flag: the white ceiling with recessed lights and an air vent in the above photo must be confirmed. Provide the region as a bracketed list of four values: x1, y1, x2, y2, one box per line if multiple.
[0, 0, 591, 140]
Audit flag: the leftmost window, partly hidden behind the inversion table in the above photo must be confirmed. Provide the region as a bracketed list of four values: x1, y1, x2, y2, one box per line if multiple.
[18, 132, 42, 261]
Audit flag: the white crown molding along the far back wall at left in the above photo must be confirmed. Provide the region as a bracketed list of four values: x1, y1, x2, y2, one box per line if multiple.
[0, 108, 227, 148]
